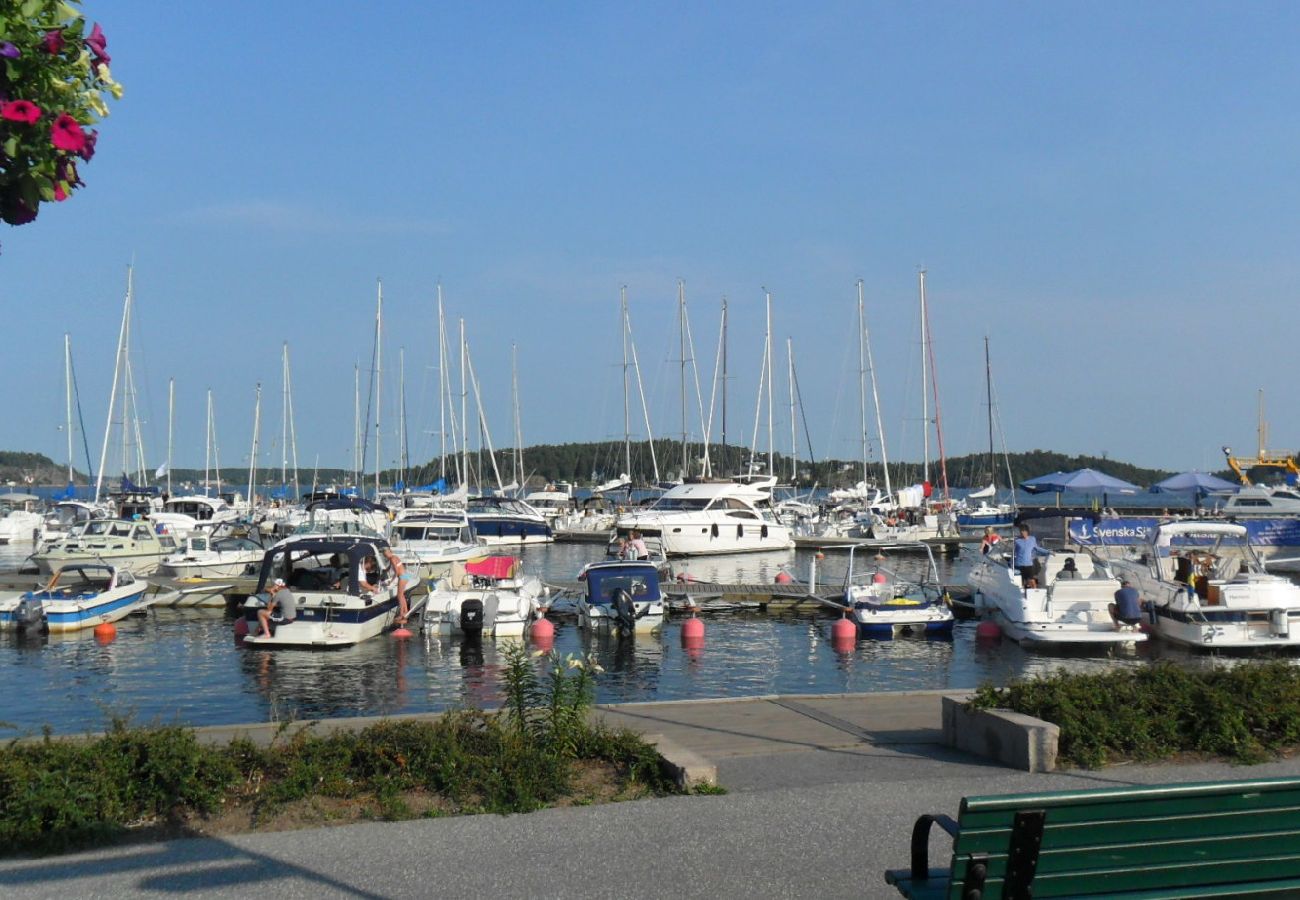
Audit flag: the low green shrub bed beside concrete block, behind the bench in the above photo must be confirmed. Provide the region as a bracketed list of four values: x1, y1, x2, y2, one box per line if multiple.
[970, 661, 1300, 769]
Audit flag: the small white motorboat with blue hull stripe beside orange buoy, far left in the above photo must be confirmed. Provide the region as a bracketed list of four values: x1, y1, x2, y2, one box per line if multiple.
[0, 562, 150, 635]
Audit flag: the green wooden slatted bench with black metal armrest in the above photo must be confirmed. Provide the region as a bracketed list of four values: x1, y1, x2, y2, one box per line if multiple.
[885, 778, 1300, 900]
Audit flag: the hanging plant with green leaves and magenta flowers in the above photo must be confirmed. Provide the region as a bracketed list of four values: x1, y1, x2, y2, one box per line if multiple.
[0, 0, 122, 239]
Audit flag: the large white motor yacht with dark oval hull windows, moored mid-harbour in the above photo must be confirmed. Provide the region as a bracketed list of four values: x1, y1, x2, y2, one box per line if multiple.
[618, 477, 794, 557]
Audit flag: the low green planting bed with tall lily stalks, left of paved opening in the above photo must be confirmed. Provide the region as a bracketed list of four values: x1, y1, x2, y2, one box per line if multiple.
[0, 649, 677, 853]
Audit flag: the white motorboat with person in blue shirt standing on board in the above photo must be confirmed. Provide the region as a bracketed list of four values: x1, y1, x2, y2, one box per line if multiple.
[967, 550, 1147, 645]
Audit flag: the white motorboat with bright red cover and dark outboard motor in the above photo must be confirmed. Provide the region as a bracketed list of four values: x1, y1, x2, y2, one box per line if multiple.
[420, 557, 545, 639]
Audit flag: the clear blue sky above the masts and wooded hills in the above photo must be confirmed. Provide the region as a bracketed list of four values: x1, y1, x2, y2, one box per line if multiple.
[0, 0, 1300, 478]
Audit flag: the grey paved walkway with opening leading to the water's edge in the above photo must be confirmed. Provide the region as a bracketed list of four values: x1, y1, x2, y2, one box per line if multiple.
[0, 692, 1300, 900]
